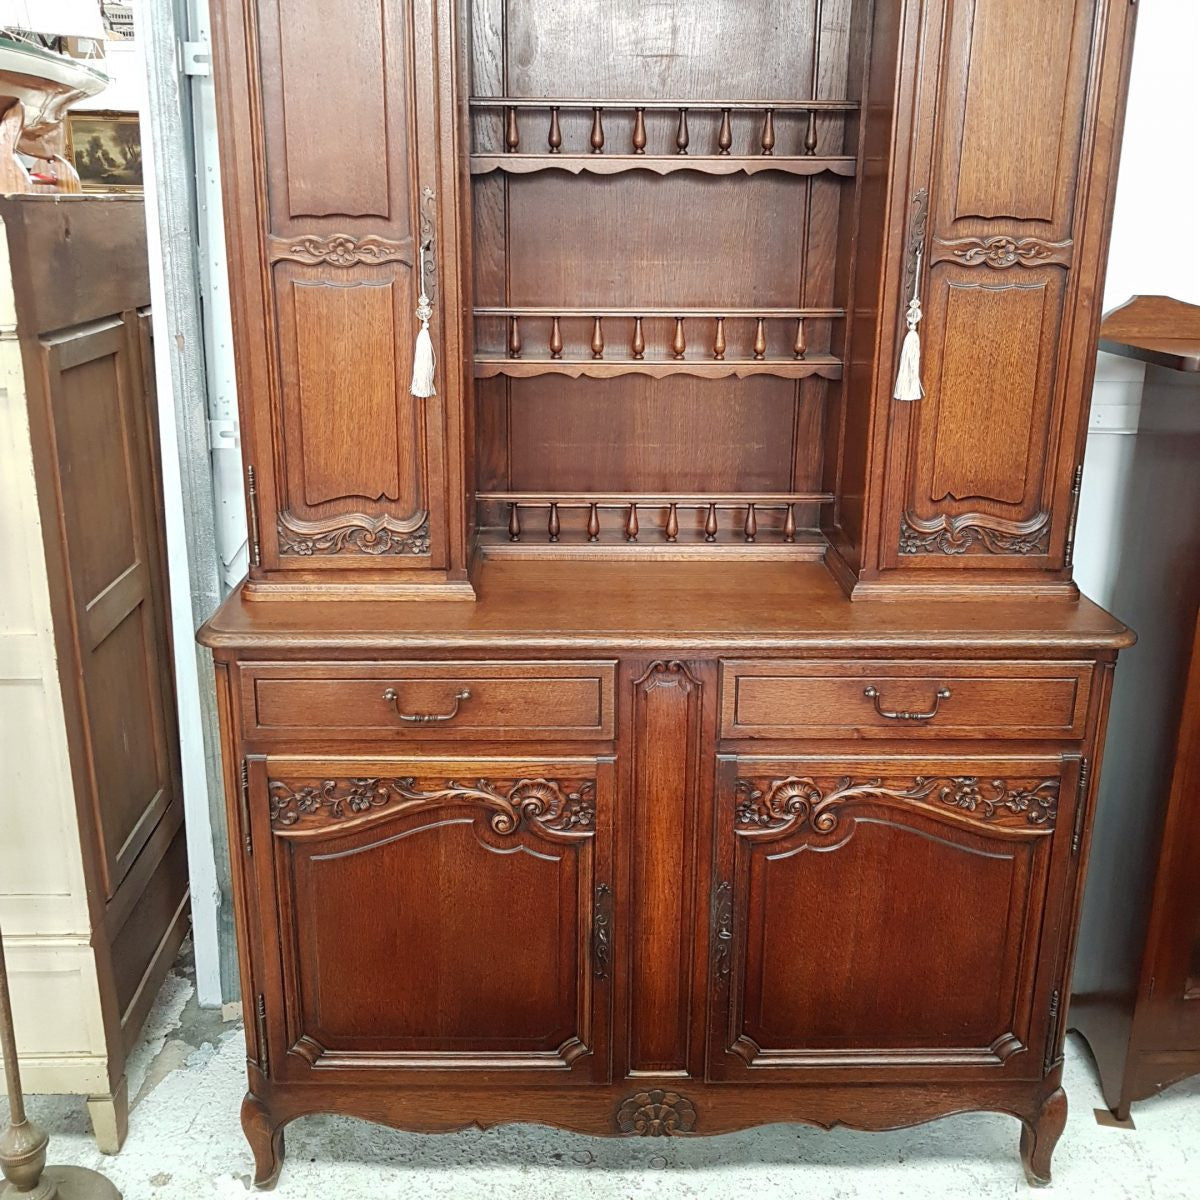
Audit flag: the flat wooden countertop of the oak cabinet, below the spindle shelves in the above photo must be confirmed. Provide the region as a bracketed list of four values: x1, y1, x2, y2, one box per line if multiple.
[199, 560, 1133, 655]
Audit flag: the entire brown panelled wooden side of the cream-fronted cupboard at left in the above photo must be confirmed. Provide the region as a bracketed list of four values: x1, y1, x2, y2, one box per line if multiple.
[7, 196, 188, 1092]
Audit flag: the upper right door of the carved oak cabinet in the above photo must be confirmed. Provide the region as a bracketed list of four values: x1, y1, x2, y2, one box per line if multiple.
[881, 0, 1129, 570]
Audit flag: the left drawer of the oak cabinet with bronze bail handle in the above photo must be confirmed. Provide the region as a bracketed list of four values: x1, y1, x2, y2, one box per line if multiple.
[241, 662, 616, 742]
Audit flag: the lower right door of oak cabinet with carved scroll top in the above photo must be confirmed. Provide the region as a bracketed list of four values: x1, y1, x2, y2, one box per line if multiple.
[708, 755, 1079, 1081]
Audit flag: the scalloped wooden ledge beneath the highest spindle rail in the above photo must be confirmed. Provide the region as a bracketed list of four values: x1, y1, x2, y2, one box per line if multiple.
[470, 154, 857, 179]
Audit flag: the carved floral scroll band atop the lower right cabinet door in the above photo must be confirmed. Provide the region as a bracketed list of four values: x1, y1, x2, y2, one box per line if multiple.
[733, 775, 1058, 836]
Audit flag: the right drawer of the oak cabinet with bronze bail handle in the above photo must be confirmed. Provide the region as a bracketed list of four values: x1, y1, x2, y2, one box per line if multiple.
[721, 660, 1092, 738]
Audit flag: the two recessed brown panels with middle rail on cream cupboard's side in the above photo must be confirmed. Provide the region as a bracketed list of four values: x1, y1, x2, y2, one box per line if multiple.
[42, 317, 180, 899]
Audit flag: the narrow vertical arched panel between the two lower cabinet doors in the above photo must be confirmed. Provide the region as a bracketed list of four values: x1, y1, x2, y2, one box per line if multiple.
[626, 661, 702, 1075]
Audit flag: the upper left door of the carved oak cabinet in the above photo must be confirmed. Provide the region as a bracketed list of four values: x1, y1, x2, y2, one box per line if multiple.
[208, 0, 456, 577]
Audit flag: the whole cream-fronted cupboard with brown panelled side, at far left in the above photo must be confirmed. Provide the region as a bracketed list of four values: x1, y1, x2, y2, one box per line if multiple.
[0, 196, 188, 1153]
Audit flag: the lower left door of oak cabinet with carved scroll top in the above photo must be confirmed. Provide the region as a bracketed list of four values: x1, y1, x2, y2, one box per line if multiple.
[248, 757, 613, 1080]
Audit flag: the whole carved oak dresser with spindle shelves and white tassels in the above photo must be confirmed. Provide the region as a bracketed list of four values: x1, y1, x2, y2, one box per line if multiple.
[202, 0, 1133, 1186]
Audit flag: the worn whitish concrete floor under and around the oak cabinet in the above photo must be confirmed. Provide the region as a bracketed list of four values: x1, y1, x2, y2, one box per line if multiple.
[9, 955, 1200, 1200]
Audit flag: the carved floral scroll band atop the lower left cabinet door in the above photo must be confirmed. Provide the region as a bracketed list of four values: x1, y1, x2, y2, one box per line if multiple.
[268, 776, 595, 836]
